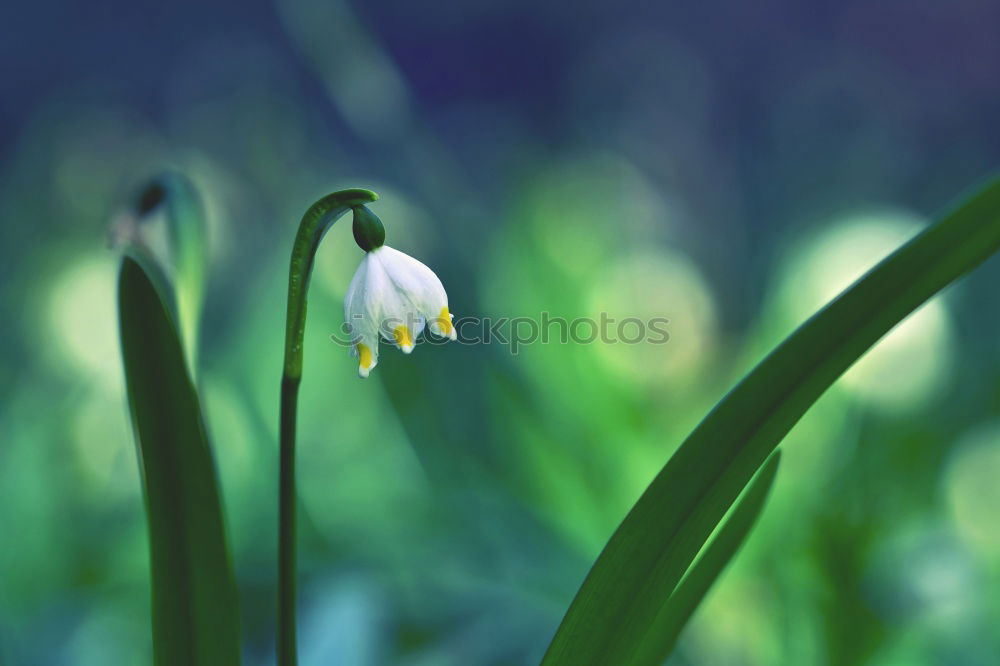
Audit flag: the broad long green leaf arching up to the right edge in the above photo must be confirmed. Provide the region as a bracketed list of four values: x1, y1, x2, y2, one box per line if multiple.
[543, 174, 1000, 666]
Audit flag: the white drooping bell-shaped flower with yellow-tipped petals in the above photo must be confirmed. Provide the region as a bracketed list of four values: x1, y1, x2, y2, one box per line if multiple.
[344, 245, 457, 377]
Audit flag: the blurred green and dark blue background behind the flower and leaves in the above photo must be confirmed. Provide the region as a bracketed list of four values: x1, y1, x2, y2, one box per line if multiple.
[0, 0, 1000, 666]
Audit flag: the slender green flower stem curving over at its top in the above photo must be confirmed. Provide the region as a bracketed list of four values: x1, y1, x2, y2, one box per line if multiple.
[277, 189, 378, 666]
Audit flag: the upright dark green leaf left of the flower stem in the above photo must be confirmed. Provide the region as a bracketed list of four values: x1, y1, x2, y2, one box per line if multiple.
[118, 257, 240, 666]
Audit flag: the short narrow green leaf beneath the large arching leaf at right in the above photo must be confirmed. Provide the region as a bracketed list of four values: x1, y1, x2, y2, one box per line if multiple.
[639, 451, 781, 663]
